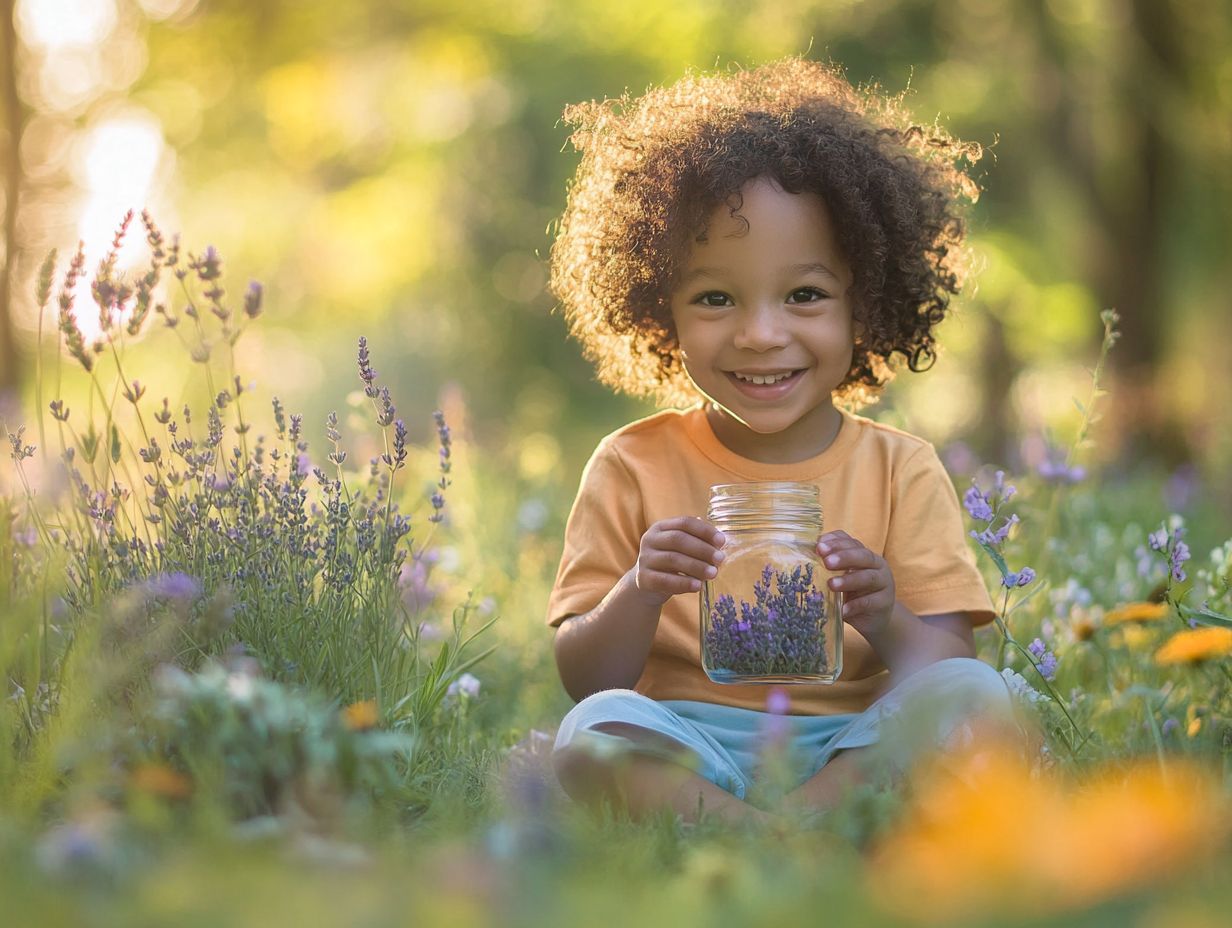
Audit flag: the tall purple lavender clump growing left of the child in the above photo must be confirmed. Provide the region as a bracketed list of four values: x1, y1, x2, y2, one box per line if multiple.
[2, 213, 490, 764]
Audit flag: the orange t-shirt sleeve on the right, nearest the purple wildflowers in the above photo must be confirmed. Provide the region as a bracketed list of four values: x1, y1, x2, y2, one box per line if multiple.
[886, 445, 995, 625]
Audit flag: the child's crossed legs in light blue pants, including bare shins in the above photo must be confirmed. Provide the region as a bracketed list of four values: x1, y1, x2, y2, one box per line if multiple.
[553, 658, 1018, 822]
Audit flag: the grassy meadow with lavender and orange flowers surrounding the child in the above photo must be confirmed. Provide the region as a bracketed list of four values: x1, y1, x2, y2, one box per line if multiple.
[0, 227, 1232, 928]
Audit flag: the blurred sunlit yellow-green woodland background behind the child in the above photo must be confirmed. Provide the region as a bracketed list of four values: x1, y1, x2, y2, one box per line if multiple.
[0, 0, 1232, 557]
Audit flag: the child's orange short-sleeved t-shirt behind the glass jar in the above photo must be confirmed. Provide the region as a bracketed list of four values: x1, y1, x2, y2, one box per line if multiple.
[547, 405, 994, 715]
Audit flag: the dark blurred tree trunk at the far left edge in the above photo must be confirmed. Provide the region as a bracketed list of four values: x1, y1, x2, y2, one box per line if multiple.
[0, 0, 25, 398]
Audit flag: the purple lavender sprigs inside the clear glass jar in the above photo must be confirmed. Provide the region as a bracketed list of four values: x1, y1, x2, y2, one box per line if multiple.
[705, 564, 827, 675]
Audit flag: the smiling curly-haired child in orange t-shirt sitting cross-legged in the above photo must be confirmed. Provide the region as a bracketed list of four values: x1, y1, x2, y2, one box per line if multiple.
[547, 58, 1010, 820]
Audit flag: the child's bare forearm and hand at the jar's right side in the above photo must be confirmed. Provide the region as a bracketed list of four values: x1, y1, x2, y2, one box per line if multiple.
[817, 531, 976, 683]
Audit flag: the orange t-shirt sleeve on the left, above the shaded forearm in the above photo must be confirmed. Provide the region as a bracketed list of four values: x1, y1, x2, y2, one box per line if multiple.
[547, 439, 646, 627]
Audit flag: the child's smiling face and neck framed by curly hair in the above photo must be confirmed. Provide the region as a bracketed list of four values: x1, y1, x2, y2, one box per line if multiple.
[671, 179, 853, 462]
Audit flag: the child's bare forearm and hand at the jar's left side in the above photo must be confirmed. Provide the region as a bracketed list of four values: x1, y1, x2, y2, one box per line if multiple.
[556, 516, 723, 701]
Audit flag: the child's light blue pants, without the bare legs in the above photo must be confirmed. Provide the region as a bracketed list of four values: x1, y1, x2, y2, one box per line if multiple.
[554, 657, 1013, 799]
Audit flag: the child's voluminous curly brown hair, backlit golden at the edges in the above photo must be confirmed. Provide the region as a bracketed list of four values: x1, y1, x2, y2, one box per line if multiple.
[549, 57, 982, 407]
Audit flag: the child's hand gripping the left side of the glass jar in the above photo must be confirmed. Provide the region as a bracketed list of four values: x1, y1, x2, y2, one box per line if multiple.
[633, 515, 724, 606]
